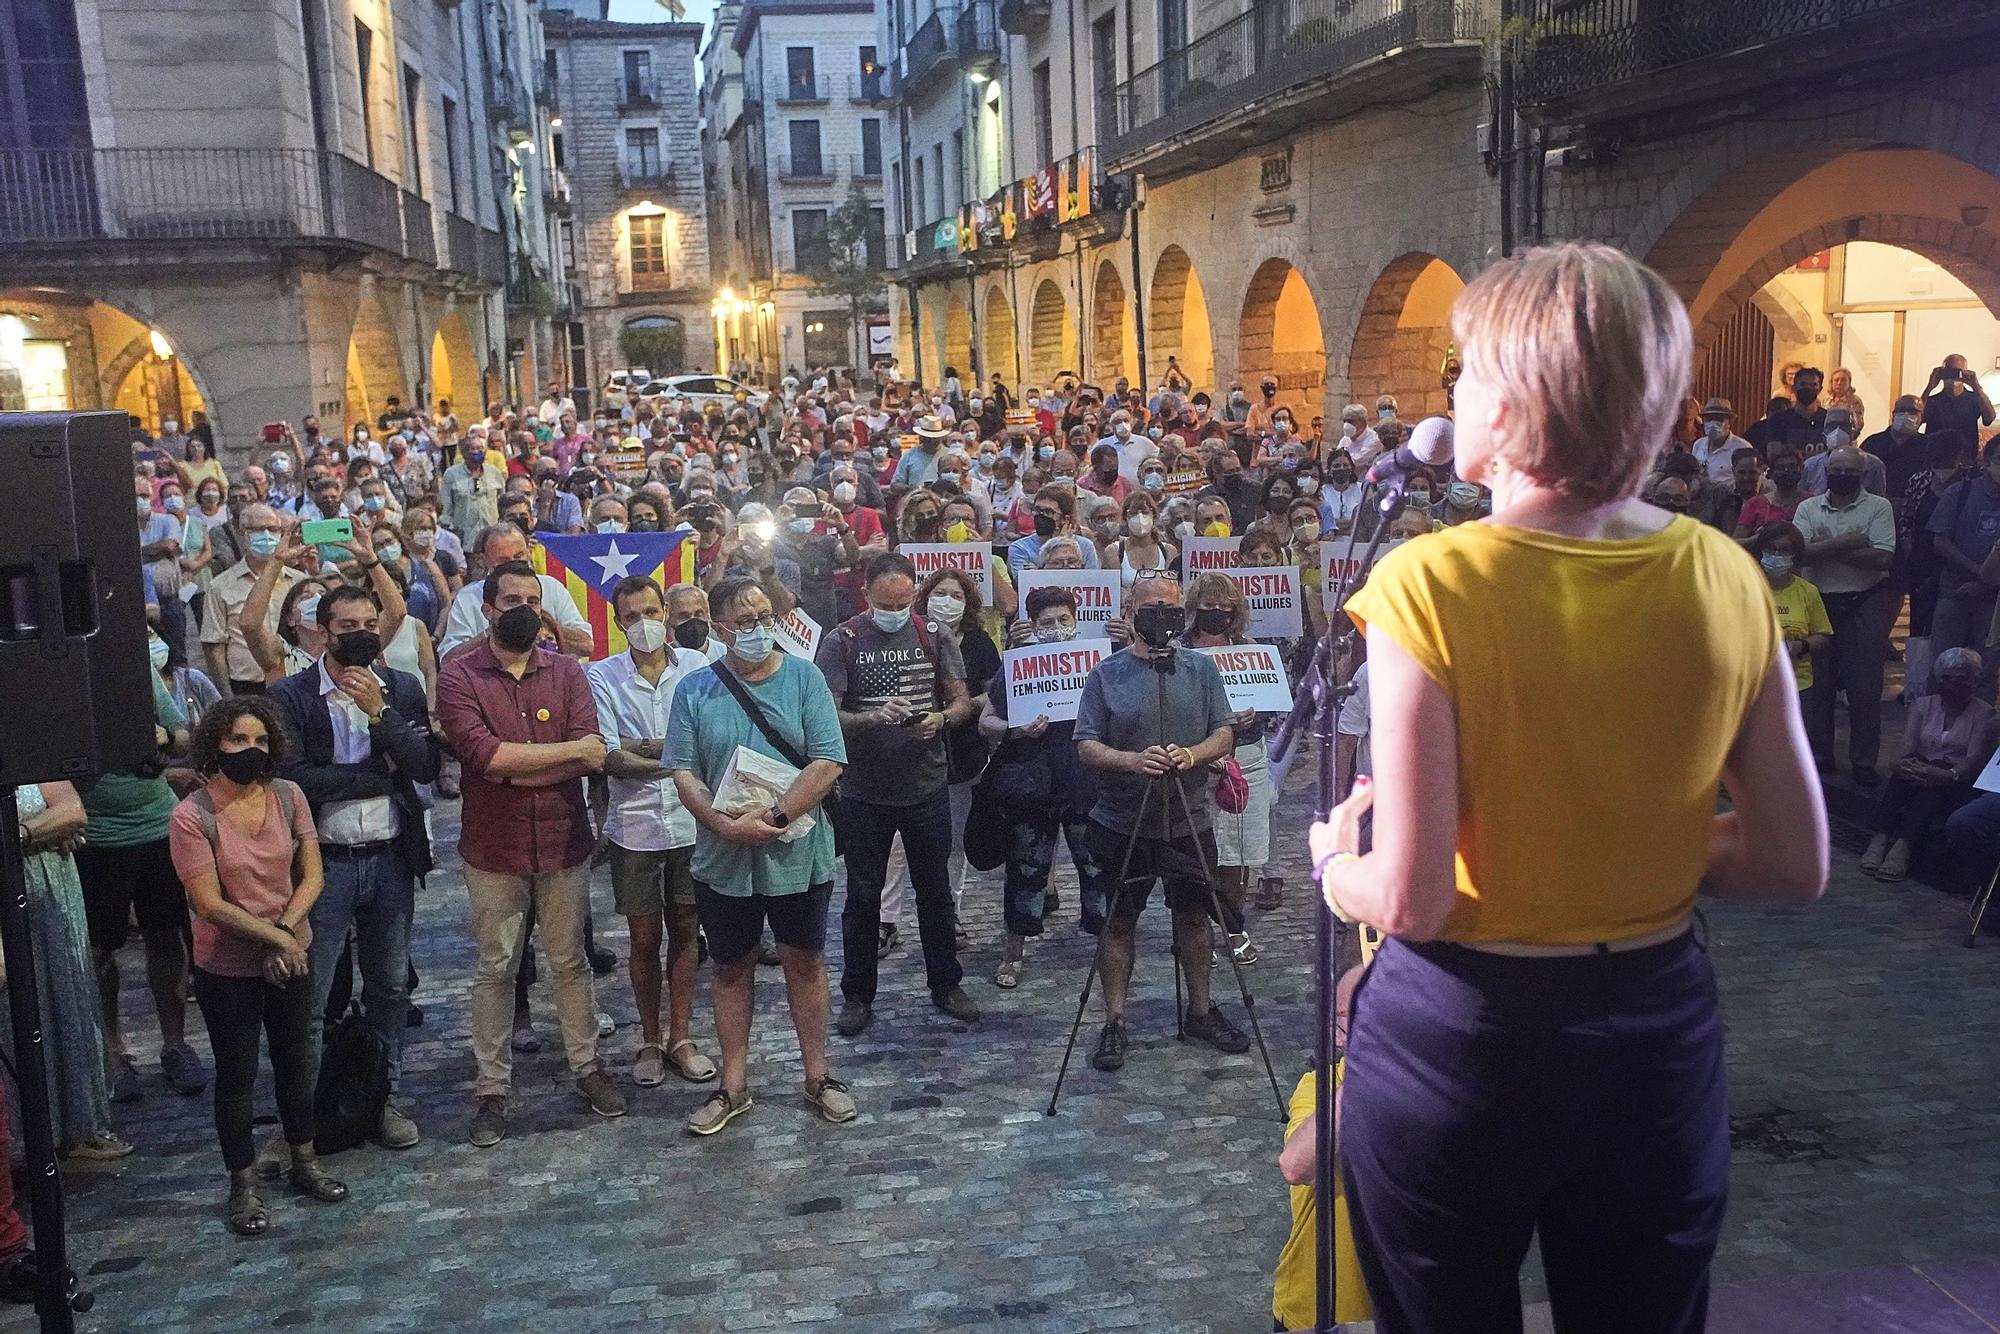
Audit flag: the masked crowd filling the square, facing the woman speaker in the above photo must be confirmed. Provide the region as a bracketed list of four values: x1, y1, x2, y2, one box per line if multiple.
[3, 336, 2000, 1272]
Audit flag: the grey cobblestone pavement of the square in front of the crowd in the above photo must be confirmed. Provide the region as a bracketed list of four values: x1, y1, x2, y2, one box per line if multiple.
[6, 766, 2000, 1334]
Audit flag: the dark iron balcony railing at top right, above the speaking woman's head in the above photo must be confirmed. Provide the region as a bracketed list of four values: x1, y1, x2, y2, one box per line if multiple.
[1516, 0, 2000, 112]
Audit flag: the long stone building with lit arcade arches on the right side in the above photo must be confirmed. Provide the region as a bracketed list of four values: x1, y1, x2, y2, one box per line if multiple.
[882, 0, 2000, 422]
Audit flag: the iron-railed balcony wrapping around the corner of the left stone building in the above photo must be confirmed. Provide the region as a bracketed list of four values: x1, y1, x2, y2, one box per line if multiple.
[0, 148, 486, 276]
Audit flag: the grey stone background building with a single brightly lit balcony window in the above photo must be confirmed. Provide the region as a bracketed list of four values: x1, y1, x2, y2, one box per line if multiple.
[546, 12, 714, 388]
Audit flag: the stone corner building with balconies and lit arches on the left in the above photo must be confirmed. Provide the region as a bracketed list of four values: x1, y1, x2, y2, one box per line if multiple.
[0, 0, 564, 456]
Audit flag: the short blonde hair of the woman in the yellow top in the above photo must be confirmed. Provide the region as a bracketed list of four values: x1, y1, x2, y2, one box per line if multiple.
[1452, 242, 1694, 504]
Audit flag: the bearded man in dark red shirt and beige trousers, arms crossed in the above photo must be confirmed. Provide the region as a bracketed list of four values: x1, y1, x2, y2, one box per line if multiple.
[438, 560, 626, 1148]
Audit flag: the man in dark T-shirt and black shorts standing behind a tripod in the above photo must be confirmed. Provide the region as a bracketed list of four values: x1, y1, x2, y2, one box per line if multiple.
[1072, 570, 1250, 1070]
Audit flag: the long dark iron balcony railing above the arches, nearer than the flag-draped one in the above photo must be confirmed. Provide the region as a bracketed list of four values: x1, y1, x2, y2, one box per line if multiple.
[1104, 0, 1486, 162]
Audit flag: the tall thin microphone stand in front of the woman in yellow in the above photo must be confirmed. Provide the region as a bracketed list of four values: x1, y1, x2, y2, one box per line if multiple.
[1272, 478, 1404, 1334]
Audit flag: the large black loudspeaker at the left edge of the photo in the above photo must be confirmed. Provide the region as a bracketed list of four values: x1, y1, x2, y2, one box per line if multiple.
[0, 412, 154, 790]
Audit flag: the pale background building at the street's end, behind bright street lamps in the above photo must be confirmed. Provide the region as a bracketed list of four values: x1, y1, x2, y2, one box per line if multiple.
[702, 0, 890, 384]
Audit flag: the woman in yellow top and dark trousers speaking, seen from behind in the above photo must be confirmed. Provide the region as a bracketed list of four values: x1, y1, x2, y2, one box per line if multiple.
[1312, 244, 1828, 1334]
